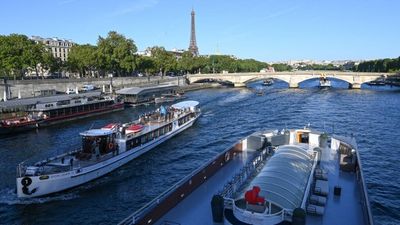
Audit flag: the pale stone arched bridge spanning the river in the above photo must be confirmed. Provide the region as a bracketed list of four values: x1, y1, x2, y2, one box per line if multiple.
[186, 71, 394, 89]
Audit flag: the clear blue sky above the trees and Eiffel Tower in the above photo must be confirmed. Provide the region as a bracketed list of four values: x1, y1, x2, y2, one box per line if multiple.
[0, 0, 400, 61]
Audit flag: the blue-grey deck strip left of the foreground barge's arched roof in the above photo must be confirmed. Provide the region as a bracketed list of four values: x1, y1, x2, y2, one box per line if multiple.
[155, 150, 255, 225]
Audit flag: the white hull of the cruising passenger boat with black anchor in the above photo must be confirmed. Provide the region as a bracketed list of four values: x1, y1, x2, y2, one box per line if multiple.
[16, 114, 200, 198]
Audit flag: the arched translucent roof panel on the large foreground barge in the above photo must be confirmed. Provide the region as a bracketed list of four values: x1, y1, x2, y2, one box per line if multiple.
[250, 145, 313, 210]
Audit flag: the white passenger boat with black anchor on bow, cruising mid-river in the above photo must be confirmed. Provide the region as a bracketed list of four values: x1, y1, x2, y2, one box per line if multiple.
[16, 101, 201, 198]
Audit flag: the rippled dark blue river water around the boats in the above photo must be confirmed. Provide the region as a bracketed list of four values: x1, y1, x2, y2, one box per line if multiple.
[0, 80, 400, 224]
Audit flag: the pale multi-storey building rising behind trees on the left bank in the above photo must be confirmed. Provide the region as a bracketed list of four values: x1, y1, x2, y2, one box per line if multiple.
[31, 36, 74, 62]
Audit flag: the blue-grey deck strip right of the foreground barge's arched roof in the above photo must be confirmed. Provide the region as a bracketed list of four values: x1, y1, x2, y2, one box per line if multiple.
[307, 145, 366, 225]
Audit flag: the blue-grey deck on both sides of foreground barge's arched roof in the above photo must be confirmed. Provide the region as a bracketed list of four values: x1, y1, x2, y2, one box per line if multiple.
[155, 144, 366, 225]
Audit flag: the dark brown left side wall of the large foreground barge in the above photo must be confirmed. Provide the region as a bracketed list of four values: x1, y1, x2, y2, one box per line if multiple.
[119, 143, 241, 225]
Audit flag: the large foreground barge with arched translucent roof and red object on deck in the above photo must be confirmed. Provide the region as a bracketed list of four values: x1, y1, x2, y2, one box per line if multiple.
[120, 127, 373, 225]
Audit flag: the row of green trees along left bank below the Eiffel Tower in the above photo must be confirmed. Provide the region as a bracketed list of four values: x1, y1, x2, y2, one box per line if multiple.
[0, 31, 272, 79]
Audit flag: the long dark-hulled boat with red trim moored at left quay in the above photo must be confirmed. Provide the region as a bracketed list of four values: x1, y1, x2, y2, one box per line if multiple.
[0, 95, 124, 134]
